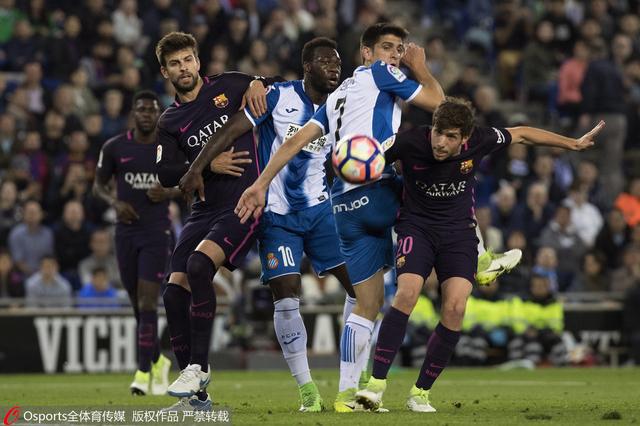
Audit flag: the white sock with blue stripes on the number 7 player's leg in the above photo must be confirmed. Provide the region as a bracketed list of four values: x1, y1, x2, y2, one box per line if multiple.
[338, 313, 373, 392]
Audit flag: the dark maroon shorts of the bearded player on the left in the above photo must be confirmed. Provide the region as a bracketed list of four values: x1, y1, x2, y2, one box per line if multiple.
[171, 210, 258, 273]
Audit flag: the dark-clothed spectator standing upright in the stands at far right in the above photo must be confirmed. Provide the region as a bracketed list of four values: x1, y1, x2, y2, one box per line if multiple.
[580, 36, 627, 205]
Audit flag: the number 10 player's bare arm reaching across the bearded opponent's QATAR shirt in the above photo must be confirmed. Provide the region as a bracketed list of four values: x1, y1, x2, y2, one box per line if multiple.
[179, 111, 253, 200]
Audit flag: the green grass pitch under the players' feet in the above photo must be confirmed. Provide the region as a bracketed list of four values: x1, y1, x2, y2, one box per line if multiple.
[0, 368, 640, 426]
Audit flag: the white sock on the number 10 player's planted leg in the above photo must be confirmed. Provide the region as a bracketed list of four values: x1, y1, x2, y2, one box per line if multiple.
[273, 297, 311, 386]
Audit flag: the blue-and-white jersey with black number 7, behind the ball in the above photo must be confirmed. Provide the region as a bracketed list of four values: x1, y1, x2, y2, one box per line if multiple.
[312, 61, 422, 196]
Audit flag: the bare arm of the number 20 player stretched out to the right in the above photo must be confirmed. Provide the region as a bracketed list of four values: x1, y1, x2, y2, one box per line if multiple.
[507, 120, 605, 151]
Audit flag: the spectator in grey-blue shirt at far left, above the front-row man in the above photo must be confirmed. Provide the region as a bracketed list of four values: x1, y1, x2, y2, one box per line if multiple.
[9, 200, 57, 275]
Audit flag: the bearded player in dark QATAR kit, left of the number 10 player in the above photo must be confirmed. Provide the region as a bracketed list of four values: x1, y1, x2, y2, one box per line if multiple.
[156, 32, 276, 409]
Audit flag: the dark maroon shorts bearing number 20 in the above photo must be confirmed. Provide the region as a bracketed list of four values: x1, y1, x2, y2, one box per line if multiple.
[395, 217, 478, 284]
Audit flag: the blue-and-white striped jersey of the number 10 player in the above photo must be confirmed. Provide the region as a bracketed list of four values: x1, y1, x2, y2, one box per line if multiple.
[245, 80, 331, 215]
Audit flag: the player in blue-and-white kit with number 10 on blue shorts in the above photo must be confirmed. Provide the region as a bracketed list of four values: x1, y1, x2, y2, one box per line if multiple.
[180, 37, 355, 412]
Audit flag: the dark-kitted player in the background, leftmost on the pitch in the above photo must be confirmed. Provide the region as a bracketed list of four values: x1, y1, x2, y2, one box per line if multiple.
[93, 91, 180, 395]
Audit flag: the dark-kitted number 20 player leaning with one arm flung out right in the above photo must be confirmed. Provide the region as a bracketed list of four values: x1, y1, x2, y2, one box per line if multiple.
[356, 98, 604, 412]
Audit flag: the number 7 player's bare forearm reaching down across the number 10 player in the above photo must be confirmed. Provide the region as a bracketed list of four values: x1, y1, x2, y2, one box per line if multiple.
[235, 122, 323, 223]
